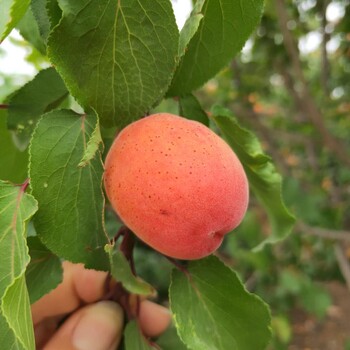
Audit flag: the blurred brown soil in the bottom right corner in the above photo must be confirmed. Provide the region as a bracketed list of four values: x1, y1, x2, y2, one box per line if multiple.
[288, 282, 350, 350]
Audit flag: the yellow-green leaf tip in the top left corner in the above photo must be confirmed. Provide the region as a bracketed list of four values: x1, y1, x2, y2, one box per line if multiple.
[0, 0, 30, 43]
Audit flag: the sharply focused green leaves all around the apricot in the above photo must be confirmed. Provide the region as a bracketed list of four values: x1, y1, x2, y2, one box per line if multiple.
[0, 0, 300, 350]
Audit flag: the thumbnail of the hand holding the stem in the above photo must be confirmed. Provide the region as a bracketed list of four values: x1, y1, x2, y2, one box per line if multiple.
[72, 301, 123, 350]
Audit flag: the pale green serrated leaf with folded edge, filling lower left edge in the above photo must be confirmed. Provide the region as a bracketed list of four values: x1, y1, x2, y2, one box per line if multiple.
[0, 181, 38, 349]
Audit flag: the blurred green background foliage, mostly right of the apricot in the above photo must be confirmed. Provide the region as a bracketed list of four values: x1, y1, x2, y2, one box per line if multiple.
[0, 0, 350, 350]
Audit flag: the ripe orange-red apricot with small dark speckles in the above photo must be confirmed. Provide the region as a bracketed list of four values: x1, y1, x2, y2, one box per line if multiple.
[104, 113, 249, 260]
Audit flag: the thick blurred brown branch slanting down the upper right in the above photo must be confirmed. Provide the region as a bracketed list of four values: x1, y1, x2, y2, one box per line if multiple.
[275, 0, 350, 167]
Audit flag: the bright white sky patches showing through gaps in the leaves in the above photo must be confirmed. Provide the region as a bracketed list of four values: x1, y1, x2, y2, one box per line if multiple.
[0, 0, 344, 76]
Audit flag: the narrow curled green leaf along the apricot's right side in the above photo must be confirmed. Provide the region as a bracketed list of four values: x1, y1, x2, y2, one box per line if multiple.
[212, 106, 295, 250]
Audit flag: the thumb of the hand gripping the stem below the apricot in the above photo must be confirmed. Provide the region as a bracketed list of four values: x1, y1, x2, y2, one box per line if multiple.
[44, 301, 124, 350]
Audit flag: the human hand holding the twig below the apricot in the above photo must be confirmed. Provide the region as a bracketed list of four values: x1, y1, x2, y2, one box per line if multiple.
[32, 262, 170, 350]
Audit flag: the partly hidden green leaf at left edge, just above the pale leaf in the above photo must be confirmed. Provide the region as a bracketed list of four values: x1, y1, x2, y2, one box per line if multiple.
[0, 110, 28, 183]
